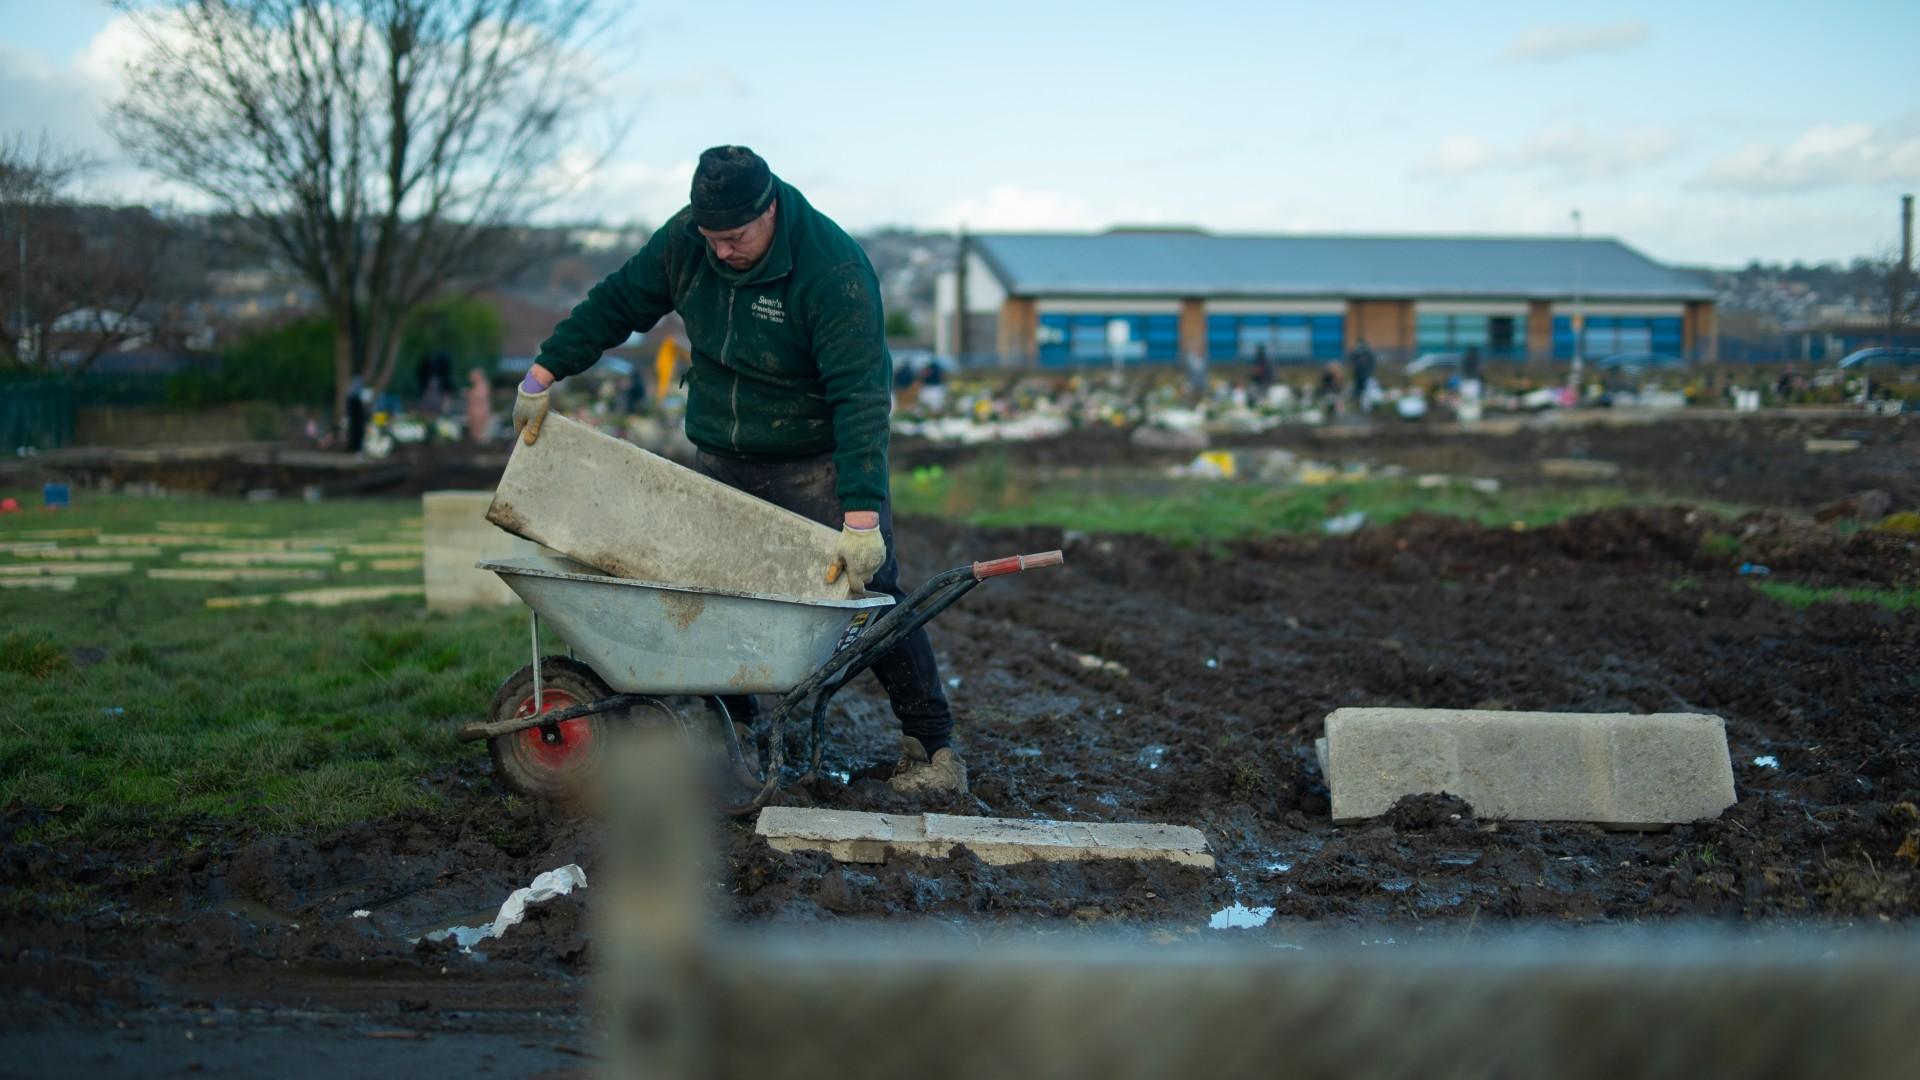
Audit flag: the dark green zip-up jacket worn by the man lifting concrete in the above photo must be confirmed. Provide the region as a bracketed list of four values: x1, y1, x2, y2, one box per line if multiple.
[540, 181, 893, 509]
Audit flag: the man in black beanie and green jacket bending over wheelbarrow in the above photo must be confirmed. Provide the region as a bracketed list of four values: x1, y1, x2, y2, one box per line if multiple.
[513, 146, 966, 792]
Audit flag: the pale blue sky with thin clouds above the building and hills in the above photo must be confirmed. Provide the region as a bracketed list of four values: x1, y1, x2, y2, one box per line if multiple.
[0, 0, 1920, 265]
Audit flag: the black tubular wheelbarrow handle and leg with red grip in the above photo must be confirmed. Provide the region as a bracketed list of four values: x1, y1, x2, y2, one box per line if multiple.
[720, 552, 1066, 817]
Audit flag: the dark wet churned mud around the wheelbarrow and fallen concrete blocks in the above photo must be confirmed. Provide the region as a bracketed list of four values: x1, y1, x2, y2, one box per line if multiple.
[0, 413, 1920, 1074]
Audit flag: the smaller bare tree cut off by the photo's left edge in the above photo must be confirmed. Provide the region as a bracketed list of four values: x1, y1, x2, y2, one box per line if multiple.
[0, 135, 167, 375]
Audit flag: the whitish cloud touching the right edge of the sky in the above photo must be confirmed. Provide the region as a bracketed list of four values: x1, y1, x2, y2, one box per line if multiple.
[1693, 111, 1920, 194]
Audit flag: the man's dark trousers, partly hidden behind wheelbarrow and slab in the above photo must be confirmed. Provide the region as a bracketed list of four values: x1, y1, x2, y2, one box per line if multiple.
[693, 450, 954, 753]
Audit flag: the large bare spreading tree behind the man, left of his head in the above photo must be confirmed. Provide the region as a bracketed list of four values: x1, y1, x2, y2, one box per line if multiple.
[111, 0, 603, 426]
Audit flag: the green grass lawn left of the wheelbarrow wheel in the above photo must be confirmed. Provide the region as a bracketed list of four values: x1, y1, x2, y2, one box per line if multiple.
[0, 492, 526, 842]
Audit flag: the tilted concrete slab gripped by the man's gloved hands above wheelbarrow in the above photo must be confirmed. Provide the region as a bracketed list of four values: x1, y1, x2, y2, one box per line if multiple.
[488, 415, 851, 600]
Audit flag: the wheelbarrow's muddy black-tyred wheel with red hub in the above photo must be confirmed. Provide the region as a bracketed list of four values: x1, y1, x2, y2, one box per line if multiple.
[488, 655, 612, 801]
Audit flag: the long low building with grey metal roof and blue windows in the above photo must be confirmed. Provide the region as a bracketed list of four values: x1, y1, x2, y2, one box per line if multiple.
[935, 229, 1715, 367]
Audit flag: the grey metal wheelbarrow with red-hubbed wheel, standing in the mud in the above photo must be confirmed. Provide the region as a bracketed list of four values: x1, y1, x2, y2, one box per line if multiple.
[459, 552, 1064, 817]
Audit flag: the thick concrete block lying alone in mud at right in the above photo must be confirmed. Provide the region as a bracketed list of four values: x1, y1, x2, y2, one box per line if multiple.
[1323, 709, 1734, 826]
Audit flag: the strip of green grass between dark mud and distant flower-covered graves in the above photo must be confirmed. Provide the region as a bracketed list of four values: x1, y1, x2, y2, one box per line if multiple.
[893, 454, 1712, 544]
